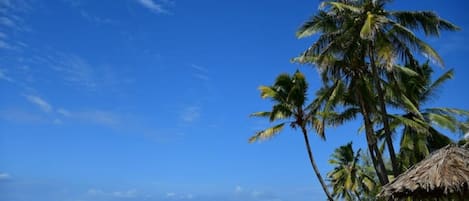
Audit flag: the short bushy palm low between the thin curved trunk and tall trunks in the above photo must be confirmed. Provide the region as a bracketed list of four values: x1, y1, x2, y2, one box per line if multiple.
[327, 142, 376, 201]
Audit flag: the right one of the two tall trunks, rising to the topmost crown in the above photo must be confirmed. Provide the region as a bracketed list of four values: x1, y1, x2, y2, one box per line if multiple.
[369, 44, 399, 177]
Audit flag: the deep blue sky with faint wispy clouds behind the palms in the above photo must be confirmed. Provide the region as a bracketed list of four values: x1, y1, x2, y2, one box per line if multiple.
[0, 0, 469, 201]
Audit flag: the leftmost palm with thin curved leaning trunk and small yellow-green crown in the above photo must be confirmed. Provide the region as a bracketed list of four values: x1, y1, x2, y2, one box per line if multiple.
[249, 71, 333, 201]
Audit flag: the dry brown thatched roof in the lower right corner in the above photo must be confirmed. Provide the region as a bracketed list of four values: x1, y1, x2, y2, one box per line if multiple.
[378, 145, 469, 200]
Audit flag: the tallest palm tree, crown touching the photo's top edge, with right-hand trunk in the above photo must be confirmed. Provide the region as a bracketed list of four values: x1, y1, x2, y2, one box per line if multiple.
[296, 0, 458, 179]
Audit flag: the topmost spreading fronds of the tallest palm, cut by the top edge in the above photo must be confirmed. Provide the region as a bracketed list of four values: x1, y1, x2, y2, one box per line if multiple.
[295, 0, 460, 67]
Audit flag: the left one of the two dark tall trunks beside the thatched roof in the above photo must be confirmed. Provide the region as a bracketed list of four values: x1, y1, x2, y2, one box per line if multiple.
[357, 88, 389, 185]
